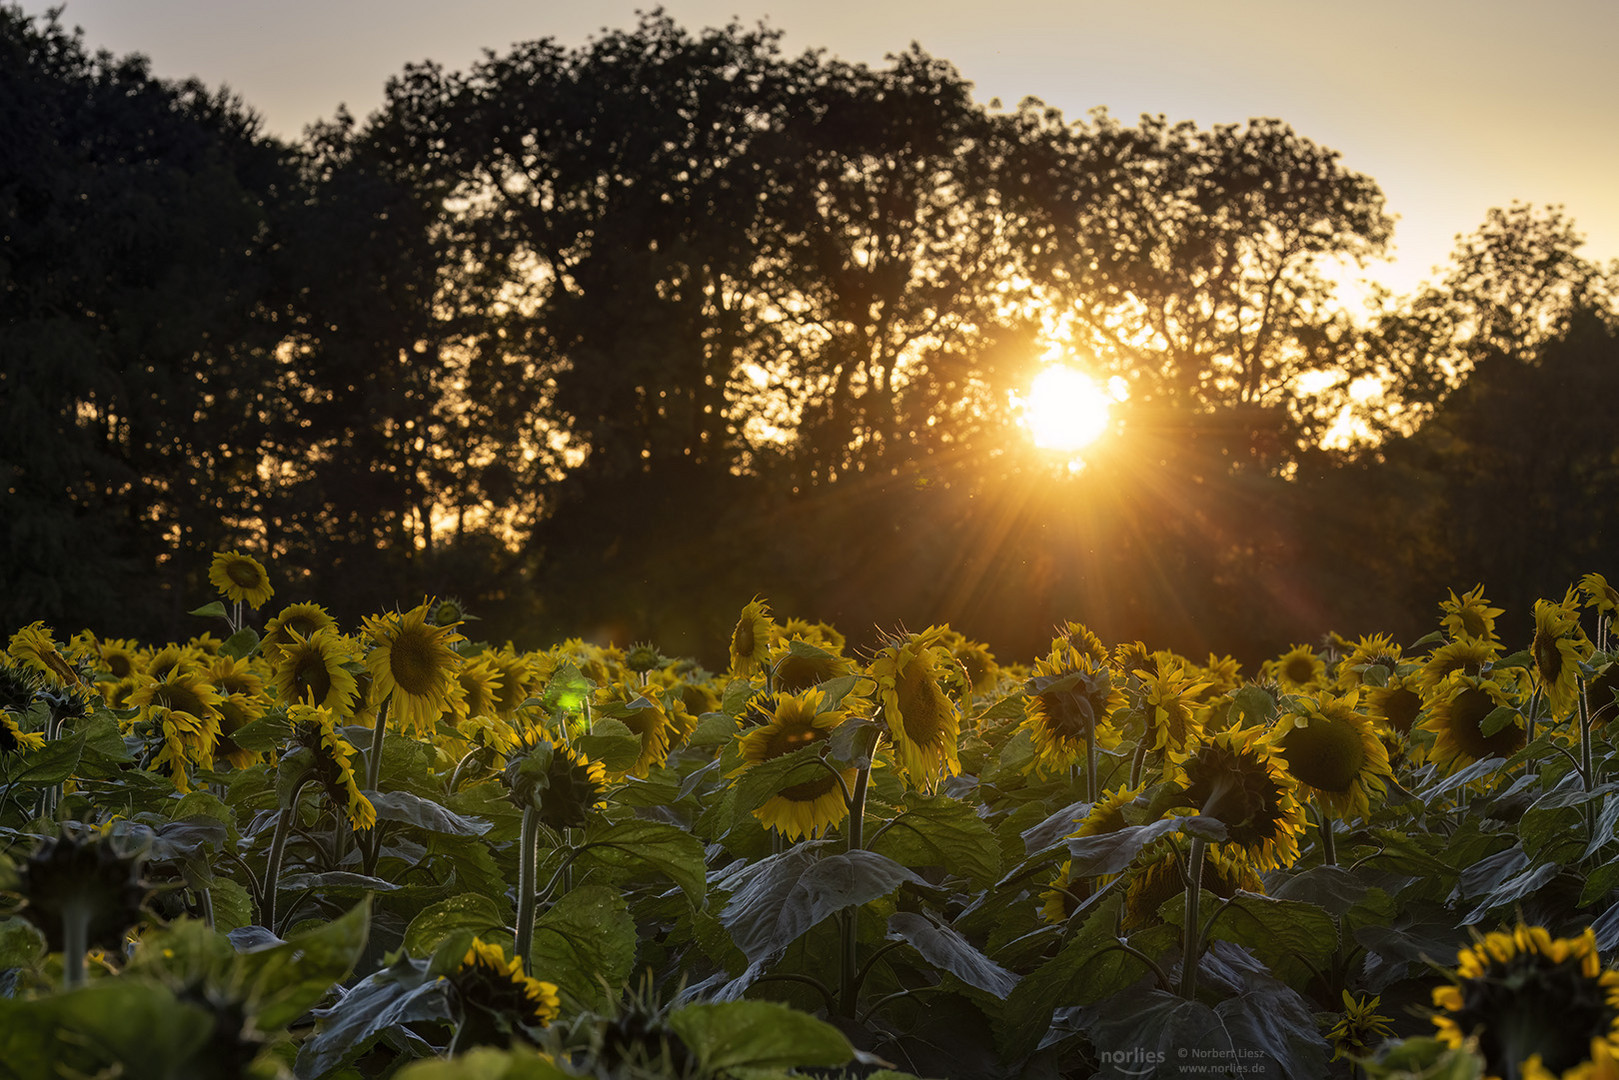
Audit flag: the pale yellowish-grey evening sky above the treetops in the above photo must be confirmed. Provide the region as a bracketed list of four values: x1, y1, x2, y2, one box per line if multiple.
[23, 0, 1619, 291]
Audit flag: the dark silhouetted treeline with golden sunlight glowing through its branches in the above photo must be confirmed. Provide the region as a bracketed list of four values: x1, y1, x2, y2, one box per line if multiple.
[0, 8, 1619, 662]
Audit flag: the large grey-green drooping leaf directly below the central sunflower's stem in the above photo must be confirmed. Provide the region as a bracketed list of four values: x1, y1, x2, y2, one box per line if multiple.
[716, 844, 926, 965]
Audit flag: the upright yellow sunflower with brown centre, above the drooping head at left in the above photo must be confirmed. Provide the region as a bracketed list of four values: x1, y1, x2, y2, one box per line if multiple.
[364, 601, 463, 737]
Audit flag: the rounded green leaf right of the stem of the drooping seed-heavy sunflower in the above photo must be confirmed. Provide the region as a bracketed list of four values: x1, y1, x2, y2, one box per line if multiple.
[529, 886, 636, 1009]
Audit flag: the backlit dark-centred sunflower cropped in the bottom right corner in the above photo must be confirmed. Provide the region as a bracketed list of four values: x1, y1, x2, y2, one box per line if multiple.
[1433, 923, 1619, 1077]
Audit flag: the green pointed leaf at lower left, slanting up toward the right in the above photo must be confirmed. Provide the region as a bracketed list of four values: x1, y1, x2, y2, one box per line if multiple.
[241, 900, 371, 1031]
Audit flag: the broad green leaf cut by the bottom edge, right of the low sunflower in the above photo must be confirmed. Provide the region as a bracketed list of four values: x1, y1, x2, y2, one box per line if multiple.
[669, 1001, 855, 1075]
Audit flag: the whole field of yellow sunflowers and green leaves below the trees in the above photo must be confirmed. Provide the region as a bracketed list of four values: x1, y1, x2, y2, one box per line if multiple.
[0, 552, 1619, 1080]
